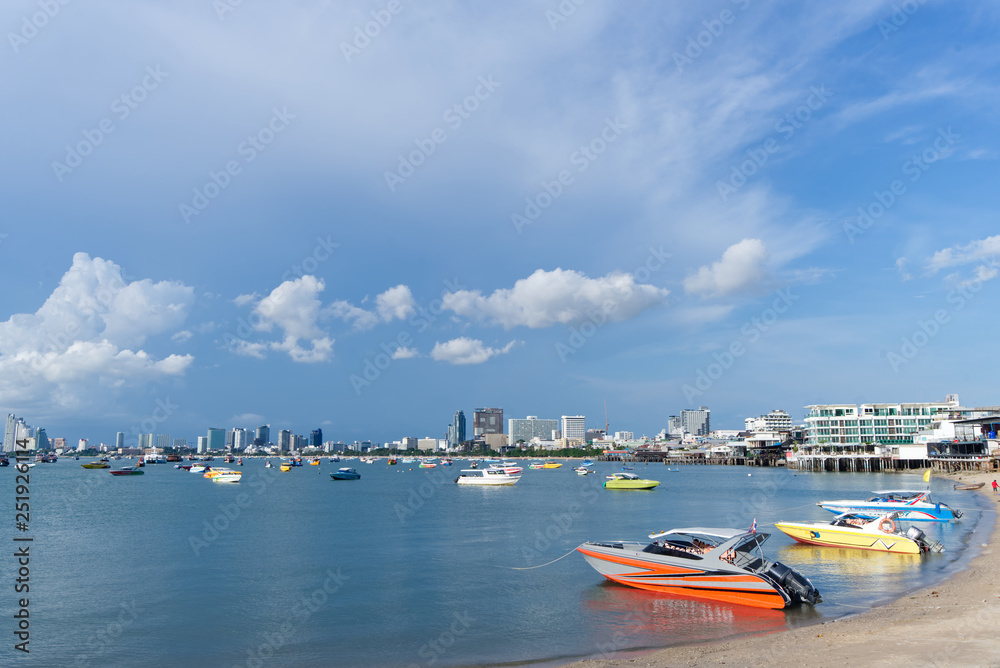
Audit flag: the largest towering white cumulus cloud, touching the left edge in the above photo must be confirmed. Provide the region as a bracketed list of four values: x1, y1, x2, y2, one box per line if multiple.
[0, 253, 194, 413]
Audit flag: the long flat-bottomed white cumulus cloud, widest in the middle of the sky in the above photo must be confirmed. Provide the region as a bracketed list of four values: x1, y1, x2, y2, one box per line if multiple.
[442, 269, 669, 329]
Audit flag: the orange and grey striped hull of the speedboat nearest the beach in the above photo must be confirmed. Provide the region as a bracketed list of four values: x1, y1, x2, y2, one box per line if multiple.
[577, 543, 790, 610]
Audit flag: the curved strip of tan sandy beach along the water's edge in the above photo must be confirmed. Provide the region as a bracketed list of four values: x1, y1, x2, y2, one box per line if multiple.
[569, 472, 1000, 668]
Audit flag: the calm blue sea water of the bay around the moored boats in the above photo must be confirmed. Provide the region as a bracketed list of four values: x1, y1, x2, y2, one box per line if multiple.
[0, 459, 993, 668]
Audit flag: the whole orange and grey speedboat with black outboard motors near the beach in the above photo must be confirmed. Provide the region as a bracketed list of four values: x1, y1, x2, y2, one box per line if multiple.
[576, 527, 820, 610]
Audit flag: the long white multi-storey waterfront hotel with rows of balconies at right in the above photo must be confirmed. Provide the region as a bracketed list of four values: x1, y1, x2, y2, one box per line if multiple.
[803, 395, 960, 449]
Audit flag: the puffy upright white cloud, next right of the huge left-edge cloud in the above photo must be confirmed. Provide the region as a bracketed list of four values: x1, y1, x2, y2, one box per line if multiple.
[230, 276, 334, 363]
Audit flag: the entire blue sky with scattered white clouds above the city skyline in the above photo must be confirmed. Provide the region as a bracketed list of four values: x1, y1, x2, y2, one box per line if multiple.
[0, 0, 1000, 443]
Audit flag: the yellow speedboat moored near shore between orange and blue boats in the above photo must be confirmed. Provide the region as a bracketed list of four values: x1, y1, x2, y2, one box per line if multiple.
[774, 513, 944, 554]
